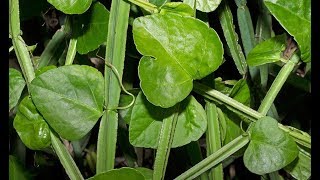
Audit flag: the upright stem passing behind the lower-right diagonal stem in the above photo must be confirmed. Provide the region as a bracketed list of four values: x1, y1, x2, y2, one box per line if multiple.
[205, 101, 223, 179]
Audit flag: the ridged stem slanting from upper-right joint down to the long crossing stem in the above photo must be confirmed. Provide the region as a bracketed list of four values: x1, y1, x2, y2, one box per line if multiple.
[258, 55, 299, 115]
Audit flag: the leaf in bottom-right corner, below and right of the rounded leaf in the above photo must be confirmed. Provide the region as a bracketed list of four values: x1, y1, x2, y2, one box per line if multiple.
[284, 149, 311, 179]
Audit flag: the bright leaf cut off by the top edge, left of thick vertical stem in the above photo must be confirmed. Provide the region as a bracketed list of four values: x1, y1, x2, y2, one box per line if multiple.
[47, 0, 92, 14]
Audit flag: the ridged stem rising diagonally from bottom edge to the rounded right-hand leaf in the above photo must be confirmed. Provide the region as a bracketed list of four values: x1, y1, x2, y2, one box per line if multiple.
[175, 135, 250, 180]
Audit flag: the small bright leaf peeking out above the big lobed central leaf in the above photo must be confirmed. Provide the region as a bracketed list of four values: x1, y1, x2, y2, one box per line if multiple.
[160, 2, 194, 17]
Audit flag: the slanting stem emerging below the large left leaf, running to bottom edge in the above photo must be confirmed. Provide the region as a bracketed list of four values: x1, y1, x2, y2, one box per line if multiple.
[50, 130, 84, 180]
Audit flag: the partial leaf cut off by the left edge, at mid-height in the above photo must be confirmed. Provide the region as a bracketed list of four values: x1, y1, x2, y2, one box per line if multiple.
[9, 68, 26, 111]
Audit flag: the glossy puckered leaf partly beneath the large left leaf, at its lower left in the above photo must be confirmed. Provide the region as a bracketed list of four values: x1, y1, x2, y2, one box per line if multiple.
[13, 96, 51, 150]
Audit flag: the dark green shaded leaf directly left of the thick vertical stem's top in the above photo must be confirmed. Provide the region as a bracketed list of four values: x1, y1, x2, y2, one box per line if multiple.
[77, 2, 109, 54]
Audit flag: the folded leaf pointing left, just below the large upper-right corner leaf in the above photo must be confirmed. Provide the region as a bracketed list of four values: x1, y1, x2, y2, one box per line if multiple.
[247, 34, 287, 66]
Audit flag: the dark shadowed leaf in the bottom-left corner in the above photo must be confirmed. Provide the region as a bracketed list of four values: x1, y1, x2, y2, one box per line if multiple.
[9, 155, 32, 180]
